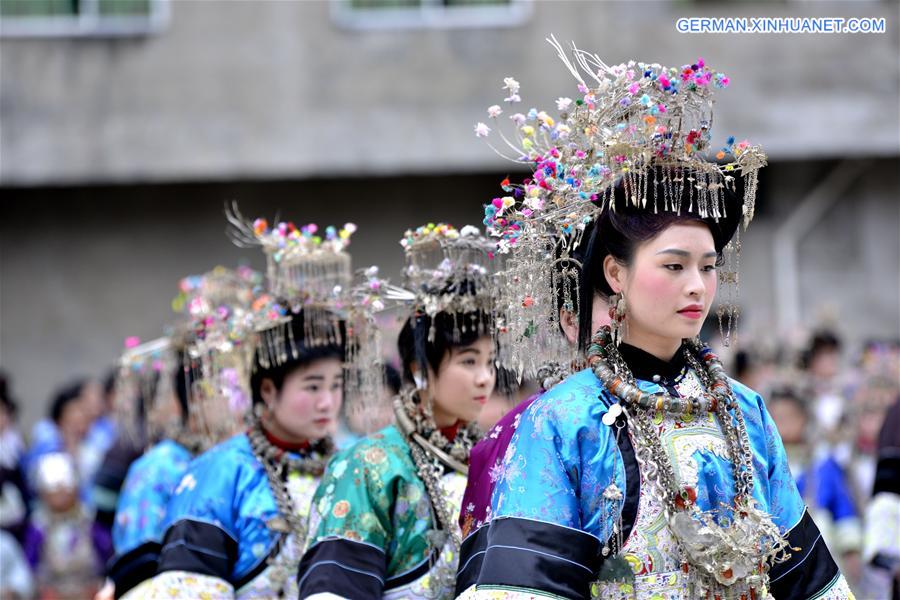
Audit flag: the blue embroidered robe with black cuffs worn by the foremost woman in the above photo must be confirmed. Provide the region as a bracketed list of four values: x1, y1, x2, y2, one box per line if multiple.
[468, 360, 847, 599]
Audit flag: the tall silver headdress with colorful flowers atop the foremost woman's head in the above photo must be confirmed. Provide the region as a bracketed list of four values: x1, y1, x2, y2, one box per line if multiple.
[479, 36, 766, 232]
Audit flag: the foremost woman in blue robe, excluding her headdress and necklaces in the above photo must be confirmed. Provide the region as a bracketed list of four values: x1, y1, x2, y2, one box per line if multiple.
[457, 166, 852, 600]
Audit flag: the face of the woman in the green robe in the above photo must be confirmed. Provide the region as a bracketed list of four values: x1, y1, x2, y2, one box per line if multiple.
[428, 336, 497, 427]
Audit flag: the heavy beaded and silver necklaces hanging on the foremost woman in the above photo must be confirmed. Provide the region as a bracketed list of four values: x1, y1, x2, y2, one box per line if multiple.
[587, 327, 790, 600]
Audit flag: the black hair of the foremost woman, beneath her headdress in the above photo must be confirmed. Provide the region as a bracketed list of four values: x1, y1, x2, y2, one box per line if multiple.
[578, 180, 742, 350]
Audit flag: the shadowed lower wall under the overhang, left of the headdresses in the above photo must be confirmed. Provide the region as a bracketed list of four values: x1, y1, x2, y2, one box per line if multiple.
[0, 176, 500, 422]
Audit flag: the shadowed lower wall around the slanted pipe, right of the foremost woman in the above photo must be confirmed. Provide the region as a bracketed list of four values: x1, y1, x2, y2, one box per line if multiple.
[740, 159, 900, 351]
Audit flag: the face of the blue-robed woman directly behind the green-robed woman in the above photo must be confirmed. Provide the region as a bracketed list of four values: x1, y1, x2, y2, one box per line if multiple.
[260, 358, 344, 442]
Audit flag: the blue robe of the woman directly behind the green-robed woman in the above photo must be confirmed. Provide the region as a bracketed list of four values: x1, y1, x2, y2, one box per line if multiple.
[150, 433, 319, 598]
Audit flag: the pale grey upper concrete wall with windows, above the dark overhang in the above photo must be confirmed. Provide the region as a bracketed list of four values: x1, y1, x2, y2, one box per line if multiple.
[0, 1, 900, 185]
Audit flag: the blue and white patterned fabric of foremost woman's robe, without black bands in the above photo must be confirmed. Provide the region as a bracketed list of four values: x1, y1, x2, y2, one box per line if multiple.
[488, 371, 803, 599]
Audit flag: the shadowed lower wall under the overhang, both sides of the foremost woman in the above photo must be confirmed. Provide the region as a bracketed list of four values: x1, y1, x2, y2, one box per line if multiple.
[0, 159, 900, 422]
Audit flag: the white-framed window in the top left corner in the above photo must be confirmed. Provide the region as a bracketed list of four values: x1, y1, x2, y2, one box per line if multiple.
[0, 0, 169, 37]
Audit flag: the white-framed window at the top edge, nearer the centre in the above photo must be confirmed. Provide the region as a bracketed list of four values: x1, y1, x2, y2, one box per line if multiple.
[331, 0, 533, 29]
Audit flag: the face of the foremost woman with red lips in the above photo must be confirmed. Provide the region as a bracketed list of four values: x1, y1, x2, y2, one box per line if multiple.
[604, 222, 717, 360]
